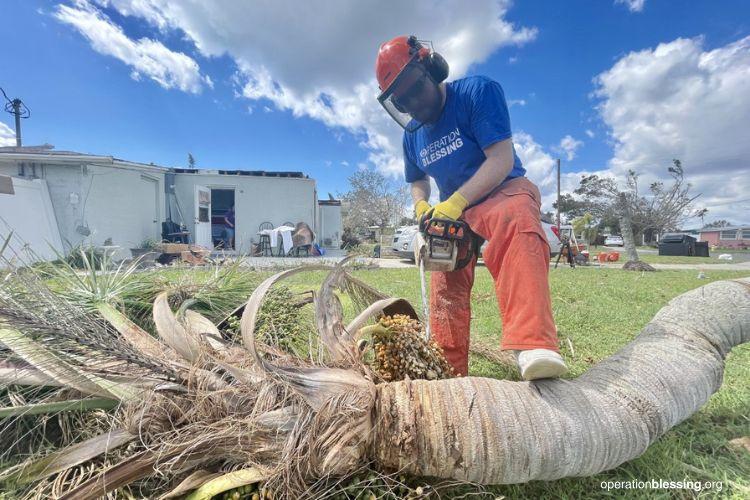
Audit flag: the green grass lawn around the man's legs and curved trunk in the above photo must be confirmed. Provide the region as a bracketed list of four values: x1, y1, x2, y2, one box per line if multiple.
[284, 267, 750, 499]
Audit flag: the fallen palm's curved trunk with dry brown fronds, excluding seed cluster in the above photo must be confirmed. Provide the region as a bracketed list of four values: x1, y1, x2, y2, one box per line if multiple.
[0, 258, 750, 499]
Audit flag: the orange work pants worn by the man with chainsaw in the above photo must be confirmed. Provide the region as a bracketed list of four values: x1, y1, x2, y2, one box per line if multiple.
[430, 177, 559, 375]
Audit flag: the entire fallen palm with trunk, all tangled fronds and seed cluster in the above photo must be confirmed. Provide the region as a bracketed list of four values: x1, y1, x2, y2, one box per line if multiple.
[0, 247, 750, 500]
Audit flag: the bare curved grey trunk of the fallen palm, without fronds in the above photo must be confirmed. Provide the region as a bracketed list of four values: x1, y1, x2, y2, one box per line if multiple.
[372, 279, 750, 484]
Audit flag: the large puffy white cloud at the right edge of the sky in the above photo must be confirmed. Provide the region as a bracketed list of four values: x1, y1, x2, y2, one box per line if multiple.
[595, 37, 750, 223]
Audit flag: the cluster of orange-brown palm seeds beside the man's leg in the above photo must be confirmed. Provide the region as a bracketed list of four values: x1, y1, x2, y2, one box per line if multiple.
[372, 314, 453, 382]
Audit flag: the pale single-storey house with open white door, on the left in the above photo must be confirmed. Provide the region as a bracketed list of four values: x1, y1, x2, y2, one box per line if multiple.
[0, 145, 342, 258]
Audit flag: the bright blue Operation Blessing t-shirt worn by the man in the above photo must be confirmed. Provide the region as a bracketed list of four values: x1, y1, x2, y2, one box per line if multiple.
[404, 76, 526, 201]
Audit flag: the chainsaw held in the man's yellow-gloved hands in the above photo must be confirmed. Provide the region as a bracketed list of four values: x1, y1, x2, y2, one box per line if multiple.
[414, 216, 481, 340]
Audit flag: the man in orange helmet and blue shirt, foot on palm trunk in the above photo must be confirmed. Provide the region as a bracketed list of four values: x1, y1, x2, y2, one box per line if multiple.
[376, 36, 567, 380]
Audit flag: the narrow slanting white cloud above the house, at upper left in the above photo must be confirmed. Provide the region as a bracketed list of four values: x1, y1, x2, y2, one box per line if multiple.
[53, 0, 213, 93]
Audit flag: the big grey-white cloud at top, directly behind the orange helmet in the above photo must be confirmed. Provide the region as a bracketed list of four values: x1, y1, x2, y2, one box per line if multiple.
[82, 0, 536, 180]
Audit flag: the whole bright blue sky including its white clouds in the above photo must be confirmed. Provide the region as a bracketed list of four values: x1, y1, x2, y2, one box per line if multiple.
[0, 0, 750, 223]
